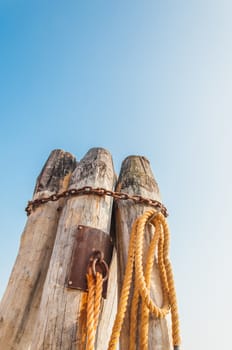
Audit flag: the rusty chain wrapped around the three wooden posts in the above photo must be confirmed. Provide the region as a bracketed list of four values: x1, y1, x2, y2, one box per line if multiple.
[25, 186, 168, 217]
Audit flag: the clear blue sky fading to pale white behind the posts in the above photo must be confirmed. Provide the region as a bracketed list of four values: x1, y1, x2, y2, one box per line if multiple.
[0, 0, 232, 350]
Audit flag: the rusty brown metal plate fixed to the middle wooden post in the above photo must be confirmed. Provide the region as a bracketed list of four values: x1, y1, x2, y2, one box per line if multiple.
[67, 225, 113, 298]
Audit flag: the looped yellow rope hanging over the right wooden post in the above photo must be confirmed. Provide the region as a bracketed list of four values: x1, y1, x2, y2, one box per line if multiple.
[108, 210, 180, 350]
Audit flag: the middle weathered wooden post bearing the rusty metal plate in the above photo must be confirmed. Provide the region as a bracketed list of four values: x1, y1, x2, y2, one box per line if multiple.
[31, 148, 117, 350]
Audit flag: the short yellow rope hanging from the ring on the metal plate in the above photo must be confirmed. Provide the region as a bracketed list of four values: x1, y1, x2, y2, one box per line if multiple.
[86, 268, 103, 350]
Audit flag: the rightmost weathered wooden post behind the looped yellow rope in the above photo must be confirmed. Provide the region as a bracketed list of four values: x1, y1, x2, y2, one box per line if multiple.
[116, 156, 172, 350]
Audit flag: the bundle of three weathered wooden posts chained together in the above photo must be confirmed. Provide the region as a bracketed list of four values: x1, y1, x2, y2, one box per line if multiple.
[0, 148, 172, 350]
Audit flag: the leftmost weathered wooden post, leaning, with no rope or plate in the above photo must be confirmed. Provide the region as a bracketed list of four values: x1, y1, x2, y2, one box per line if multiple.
[0, 150, 76, 350]
